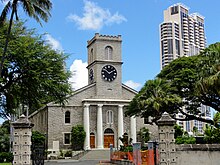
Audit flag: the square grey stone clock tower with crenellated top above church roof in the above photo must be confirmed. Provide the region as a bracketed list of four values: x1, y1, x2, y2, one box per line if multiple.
[87, 33, 122, 99]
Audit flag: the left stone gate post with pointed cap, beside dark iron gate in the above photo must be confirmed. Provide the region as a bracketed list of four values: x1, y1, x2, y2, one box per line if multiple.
[12, 115, 33, 165]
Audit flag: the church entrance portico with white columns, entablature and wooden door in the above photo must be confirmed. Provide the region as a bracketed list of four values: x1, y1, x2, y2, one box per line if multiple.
[83, 99, 136, 150]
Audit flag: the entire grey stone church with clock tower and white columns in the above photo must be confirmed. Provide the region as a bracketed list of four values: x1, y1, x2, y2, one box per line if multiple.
[29, 33, 155, 150]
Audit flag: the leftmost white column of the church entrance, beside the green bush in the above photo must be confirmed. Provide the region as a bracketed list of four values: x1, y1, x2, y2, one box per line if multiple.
[83, 104, 90, 150]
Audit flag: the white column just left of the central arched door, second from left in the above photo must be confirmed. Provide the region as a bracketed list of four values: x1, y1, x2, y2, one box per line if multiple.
[97, 104, 104, 149]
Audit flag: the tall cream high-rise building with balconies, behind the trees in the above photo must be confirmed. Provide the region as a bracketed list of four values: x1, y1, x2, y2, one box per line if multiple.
[160, 3, 211, 133]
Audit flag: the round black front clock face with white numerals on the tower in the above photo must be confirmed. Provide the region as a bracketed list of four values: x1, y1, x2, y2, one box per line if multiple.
[101, 65, 117, 82]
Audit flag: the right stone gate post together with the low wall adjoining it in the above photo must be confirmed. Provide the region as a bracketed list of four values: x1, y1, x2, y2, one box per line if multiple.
[158, 113, 220, 165]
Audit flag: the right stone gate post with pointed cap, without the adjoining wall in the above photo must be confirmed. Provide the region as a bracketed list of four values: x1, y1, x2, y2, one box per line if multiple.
[158, 112, 176, 165]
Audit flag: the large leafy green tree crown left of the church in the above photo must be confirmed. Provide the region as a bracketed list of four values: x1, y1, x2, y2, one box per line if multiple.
[0, 22, 71, 117]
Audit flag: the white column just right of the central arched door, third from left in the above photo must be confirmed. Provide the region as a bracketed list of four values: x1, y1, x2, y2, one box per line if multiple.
[118, 105, 124, 147]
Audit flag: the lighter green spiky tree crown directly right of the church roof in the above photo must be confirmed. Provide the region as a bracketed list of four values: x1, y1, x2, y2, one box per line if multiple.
[126, 78, 181, 124]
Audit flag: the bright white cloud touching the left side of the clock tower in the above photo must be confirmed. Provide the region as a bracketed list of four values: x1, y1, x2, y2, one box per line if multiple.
[69, 60, 88, 90]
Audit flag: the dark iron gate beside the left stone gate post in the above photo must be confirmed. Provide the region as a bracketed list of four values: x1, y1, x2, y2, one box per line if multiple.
[31, 144, 46, 165]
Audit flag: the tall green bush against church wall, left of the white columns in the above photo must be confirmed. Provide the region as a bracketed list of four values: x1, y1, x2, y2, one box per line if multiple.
[71, 125, 85, 150]
